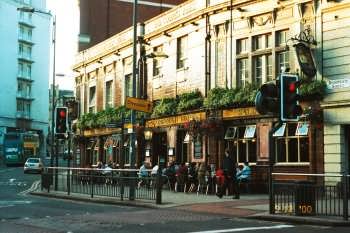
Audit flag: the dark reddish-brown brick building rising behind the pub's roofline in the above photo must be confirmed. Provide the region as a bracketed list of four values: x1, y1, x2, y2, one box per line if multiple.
[79, 0, 185, 51]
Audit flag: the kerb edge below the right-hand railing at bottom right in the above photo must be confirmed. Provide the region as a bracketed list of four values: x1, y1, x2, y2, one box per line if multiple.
[245, 214, 350, 227]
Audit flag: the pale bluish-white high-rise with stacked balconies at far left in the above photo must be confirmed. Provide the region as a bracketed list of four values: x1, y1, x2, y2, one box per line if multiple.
[0, 0, 51, 158]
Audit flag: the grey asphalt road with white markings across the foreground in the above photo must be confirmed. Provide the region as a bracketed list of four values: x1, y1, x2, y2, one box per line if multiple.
[0, 167, 349, 233]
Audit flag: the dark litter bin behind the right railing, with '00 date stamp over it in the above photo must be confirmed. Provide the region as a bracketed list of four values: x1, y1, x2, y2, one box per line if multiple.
[295, 181, 316, 216]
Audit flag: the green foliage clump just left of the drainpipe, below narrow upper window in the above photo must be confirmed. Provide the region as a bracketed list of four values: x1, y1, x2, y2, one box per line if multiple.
[176, 90, 203, 113]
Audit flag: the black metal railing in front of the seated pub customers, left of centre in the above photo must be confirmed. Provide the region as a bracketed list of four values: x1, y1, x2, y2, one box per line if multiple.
[41, 167, 161, 204]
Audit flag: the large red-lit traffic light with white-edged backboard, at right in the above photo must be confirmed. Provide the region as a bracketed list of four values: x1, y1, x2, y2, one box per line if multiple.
[280, 74, 303, 121]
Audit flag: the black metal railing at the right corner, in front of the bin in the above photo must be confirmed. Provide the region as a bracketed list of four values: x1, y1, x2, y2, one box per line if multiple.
[270, 173, 350, 220]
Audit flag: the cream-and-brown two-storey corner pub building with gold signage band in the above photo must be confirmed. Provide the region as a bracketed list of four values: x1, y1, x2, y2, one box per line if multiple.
[73, 0, 324, 189]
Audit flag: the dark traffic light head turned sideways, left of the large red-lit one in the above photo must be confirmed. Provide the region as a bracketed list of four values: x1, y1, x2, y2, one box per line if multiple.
[255, 82, 279, 115]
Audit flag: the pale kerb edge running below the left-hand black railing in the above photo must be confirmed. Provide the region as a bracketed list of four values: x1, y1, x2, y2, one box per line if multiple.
[29, 192, 161, 209]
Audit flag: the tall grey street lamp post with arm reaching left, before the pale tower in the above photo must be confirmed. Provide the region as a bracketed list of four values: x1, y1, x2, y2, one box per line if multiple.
[17, 7, 58, 186]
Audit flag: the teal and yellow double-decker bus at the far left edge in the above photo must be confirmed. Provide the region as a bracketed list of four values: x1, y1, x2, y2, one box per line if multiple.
[3, 132, 40, 166]
